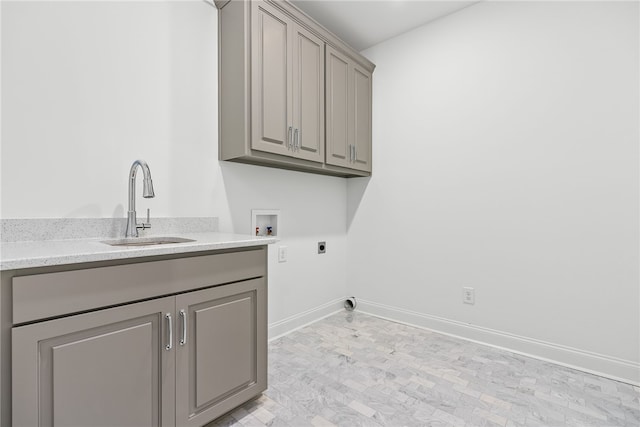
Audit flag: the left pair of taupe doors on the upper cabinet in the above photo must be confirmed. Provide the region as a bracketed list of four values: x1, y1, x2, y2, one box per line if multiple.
[251, 2, 324, 163]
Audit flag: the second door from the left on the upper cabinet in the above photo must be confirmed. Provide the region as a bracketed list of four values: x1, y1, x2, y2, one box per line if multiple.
[293, 25, 324, 162]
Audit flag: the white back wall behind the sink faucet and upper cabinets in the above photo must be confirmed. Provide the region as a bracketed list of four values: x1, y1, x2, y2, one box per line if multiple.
[1, 0, 346, 333]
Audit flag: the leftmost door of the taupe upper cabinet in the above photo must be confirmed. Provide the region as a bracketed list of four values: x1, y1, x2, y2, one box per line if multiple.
[252, 2, 293, 155]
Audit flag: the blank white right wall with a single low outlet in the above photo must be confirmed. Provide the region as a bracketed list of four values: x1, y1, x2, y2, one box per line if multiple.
[348, 2, 640, 382]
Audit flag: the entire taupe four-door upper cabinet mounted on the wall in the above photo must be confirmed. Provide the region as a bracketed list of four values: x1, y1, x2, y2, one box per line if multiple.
[218, 0, 375, 177]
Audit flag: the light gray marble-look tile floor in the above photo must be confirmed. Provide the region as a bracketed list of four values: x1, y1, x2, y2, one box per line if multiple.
[213, 311, 640, 427]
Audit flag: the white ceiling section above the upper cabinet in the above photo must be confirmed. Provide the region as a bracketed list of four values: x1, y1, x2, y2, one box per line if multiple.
[291, 0, 477, 51]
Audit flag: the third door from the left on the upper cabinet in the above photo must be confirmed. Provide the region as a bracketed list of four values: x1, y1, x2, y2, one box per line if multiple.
[326, 46, 352, 167]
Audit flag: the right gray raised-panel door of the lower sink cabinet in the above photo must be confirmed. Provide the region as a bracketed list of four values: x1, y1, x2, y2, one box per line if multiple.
[176, 278, 267, 426]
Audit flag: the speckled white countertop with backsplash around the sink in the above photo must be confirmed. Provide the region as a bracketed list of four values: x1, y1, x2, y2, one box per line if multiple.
[0, 218, 276, 270]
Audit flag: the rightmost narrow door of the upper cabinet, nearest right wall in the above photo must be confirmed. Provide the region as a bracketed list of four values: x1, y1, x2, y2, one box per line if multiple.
[351, 65, 371, 172]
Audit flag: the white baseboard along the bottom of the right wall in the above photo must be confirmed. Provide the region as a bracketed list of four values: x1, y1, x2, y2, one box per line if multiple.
[357, 298, 640, 386]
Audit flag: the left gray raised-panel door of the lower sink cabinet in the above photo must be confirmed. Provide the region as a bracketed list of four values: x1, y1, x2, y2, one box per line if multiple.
[12, 297, 175, 427]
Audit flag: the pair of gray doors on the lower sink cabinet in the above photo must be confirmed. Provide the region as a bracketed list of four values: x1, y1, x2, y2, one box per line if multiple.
[12, 277, 267, 427]
